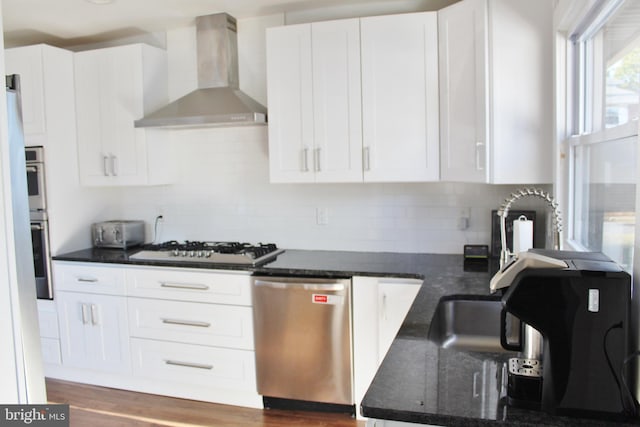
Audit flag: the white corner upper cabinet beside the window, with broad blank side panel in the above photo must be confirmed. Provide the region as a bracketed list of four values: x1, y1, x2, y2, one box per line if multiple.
[438, 0, 553, 184]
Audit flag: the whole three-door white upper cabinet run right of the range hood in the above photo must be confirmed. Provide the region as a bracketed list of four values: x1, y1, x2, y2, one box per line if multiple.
[267, 12, 439, 182]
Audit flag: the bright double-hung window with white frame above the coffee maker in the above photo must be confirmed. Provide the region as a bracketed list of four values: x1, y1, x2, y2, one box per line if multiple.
[568, 0, 640, 272]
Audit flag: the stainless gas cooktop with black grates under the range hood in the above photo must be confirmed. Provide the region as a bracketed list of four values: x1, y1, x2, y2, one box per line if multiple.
[129, 240, 284, 266]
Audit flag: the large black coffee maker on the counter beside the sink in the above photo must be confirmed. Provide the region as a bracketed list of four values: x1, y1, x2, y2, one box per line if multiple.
[497, 249, 635, 419]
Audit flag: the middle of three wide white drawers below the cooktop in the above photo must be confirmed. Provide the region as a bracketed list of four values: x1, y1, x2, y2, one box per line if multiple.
[129, 298, 253, 350]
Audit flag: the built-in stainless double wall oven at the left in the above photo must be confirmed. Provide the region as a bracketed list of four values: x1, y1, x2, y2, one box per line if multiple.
[24, 147, 53, 299]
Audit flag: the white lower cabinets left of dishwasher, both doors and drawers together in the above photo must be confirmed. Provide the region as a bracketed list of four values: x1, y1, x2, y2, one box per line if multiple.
[48, 261, 262, 408]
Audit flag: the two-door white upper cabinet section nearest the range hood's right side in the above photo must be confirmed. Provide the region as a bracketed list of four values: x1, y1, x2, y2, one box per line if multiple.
[267, 19, 362, 182]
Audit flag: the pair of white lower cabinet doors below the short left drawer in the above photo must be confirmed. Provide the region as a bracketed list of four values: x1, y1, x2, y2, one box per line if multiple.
[56, 292, 131, 373]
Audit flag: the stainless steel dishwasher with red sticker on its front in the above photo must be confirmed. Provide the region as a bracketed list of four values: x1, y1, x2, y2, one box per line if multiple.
[252, 277, 354, 406]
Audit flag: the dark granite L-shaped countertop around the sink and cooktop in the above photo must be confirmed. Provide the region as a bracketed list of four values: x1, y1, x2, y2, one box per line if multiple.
[54, 249, 640, 426]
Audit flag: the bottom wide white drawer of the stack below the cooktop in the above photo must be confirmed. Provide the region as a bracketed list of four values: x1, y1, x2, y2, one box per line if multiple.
[131, 338, 256, 392]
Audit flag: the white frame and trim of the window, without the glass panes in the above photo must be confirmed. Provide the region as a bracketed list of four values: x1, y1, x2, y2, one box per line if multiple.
[554, 0, 640, 260]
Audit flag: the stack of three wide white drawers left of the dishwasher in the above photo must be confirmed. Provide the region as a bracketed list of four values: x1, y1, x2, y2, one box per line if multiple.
[126, 267, 261, 406]
